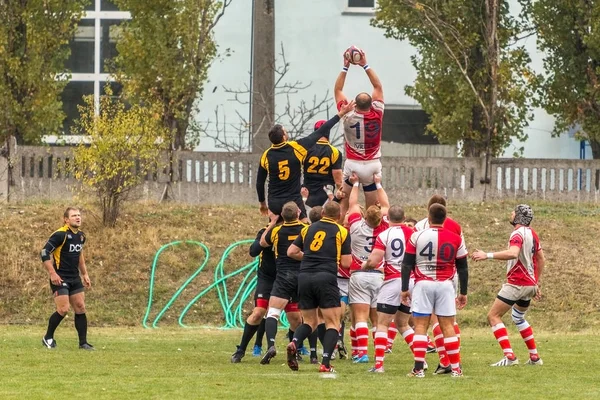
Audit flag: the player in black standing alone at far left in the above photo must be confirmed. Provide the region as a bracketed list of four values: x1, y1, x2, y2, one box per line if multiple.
[42, 207, 94, 350]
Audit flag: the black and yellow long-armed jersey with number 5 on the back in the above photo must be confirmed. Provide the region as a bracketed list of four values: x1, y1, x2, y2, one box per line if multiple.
[256, 115, 340, 202]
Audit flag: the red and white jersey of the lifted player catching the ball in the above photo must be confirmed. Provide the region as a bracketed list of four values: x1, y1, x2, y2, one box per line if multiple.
[337, 100, 384, 160]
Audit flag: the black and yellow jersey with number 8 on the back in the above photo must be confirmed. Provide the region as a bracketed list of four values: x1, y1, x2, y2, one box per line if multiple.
[294, 217, 352, 275]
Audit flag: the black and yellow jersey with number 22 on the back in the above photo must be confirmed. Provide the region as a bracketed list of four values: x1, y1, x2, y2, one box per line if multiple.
[304, 139, 342, 193]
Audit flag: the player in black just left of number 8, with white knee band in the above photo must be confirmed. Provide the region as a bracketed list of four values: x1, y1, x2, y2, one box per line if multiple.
[260, 201, 307, 364]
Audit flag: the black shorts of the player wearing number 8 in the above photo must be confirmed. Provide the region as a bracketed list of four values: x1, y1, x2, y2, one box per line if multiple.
[298, 272, 341, 310]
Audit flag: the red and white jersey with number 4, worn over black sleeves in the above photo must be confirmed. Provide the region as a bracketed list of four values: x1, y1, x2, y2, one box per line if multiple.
[406, 227, 468, 283]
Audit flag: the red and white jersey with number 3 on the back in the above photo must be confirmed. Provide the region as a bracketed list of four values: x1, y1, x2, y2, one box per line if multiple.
[348, 213, 390, 271]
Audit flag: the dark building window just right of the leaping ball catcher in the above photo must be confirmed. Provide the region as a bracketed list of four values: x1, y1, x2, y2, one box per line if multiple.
[381, 106, 440, 144]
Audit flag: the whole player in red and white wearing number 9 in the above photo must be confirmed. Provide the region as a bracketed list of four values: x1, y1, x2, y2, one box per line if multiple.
[362, 206, 414, 373]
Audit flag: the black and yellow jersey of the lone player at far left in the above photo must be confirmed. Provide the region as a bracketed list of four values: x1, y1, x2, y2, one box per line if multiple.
[42, 225, 85, 278]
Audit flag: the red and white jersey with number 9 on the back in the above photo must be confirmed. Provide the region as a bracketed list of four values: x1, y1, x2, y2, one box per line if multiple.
[373, 225, 414, 281]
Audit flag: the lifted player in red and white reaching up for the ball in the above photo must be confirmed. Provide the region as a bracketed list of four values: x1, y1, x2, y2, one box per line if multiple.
[333, 47, 384, 215]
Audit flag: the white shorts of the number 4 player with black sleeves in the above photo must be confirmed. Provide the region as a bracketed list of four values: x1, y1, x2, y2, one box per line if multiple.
[411, 281, 456, 317]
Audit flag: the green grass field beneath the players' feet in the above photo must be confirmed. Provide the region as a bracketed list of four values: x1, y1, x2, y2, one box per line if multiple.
[0, 323, 600, 400]
